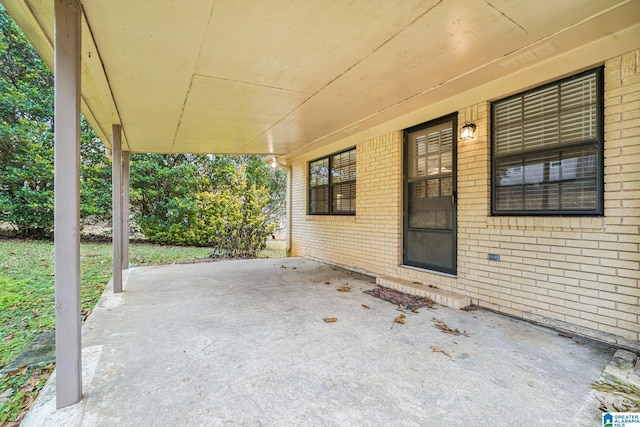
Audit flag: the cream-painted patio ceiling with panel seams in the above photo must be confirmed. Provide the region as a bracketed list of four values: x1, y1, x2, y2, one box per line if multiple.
[2, 0, 640, 155]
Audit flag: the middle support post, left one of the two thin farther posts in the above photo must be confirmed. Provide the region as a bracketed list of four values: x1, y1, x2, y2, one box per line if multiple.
[111, 125, 122, 293]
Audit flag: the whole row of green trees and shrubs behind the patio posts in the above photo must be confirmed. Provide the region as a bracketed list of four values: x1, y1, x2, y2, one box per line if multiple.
[0, 5, 285, 246]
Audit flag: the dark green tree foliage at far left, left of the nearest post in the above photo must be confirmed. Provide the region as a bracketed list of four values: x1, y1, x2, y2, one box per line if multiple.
[0, 8, 53, 237]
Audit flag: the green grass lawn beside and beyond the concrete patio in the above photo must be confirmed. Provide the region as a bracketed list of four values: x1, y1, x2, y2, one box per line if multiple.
[0, 240, 285, 426]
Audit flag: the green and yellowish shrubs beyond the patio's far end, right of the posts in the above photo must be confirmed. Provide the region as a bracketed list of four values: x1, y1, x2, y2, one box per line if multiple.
[131, 154, 275, 257]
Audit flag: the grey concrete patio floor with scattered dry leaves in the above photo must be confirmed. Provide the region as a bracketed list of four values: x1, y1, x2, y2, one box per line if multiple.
[22, 258, 613, 426]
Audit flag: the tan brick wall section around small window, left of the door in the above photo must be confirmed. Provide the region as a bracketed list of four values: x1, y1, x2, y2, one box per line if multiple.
[291, 131, 402, 273]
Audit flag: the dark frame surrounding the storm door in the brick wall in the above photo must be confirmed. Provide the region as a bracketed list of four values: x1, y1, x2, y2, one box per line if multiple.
[402, 113, 458, 276]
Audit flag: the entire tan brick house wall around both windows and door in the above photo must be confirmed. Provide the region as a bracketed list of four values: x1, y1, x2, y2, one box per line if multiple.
[292, 50, 640, 349]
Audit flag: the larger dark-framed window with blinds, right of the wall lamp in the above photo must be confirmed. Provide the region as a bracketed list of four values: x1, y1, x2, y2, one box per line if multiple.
[491, 67, 604, 215]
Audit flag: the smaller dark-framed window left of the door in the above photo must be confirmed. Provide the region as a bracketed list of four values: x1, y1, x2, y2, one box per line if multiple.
[309, 148, 356, 215]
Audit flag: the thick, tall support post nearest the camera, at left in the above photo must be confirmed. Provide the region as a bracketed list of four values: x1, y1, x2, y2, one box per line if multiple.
[54, 0, 82, 408]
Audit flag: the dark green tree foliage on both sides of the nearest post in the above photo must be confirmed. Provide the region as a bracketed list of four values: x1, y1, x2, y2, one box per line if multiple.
[0, 6, 111, 238]
